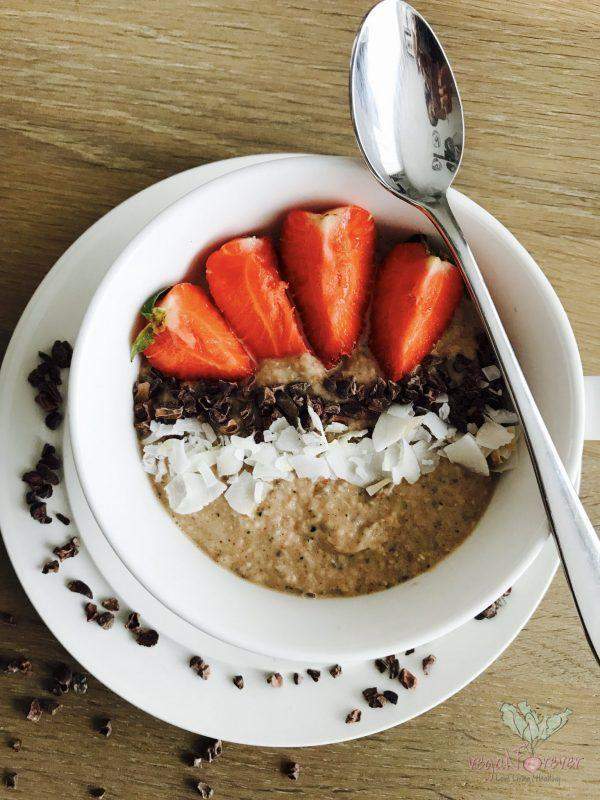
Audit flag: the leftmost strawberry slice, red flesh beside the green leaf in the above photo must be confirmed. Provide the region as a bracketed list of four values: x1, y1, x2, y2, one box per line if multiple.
[144, 283, 254, 380]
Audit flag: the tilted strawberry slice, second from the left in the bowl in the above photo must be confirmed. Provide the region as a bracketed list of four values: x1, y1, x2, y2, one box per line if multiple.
[206, 236, 308, 359]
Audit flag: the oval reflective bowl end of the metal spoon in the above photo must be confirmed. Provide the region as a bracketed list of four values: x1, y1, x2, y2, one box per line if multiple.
[350, 0, 464, 202]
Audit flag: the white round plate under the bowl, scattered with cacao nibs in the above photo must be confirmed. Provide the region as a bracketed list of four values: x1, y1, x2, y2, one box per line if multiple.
[0, 156, 592, 747]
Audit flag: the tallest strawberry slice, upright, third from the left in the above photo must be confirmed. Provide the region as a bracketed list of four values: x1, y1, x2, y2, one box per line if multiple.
[281, 206, 375, 368]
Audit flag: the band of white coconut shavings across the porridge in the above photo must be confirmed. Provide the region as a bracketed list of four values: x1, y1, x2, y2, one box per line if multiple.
[142, 394, 516, 516]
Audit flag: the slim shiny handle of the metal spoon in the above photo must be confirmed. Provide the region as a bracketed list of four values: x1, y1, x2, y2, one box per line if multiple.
[424, 197, 600, 663]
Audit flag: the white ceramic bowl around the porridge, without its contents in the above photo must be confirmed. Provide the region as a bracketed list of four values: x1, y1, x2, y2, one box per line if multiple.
[69, 156, 583, 663]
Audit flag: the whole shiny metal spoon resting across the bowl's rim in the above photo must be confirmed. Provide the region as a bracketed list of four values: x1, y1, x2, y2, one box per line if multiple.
[350, 0, 600, 663]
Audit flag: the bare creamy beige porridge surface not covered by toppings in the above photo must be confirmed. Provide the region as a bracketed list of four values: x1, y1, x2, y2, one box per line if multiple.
[138, 300, 504, 596]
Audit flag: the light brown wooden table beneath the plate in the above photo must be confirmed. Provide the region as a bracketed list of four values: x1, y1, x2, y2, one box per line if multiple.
[0, 0, 600, 800]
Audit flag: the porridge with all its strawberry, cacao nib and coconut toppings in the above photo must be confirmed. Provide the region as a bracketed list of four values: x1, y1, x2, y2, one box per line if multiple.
[134, 207, 516, 596]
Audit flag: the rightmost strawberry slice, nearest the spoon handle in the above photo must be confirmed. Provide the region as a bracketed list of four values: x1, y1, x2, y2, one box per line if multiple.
[370, 242, 463, 380]
